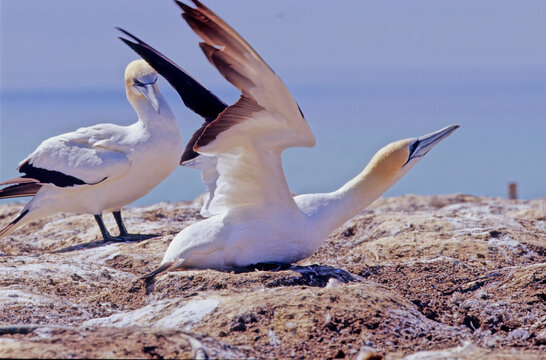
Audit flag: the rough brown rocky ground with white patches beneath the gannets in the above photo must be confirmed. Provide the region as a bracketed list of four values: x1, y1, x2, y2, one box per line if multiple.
[0, 195, 546, 359]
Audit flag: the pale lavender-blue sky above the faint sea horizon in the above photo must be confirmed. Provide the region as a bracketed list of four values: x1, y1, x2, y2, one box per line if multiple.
[4, 0, 546, 90]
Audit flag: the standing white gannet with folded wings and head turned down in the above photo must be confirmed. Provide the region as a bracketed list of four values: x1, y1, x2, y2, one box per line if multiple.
[0, 60, 182, 241]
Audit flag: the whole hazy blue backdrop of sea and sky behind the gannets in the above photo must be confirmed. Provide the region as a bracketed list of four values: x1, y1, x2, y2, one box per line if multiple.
[0, 0, 546, 204]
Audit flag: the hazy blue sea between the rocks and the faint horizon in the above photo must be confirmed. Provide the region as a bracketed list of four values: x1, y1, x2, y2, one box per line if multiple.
[0, 70, 546, 205]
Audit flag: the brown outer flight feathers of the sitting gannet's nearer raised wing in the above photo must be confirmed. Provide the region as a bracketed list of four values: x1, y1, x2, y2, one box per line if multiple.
[180, 0, 314, 151]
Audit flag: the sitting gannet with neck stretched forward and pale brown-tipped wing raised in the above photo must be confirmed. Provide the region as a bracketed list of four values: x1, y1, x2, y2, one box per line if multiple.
[130, 0, 459, 278]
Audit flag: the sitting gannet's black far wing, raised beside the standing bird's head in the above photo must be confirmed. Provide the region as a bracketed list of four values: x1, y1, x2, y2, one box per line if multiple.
[117, 28, 227, 164]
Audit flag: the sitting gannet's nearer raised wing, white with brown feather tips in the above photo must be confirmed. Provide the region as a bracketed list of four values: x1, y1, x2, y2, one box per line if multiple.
[177, 0, 315, 214]
